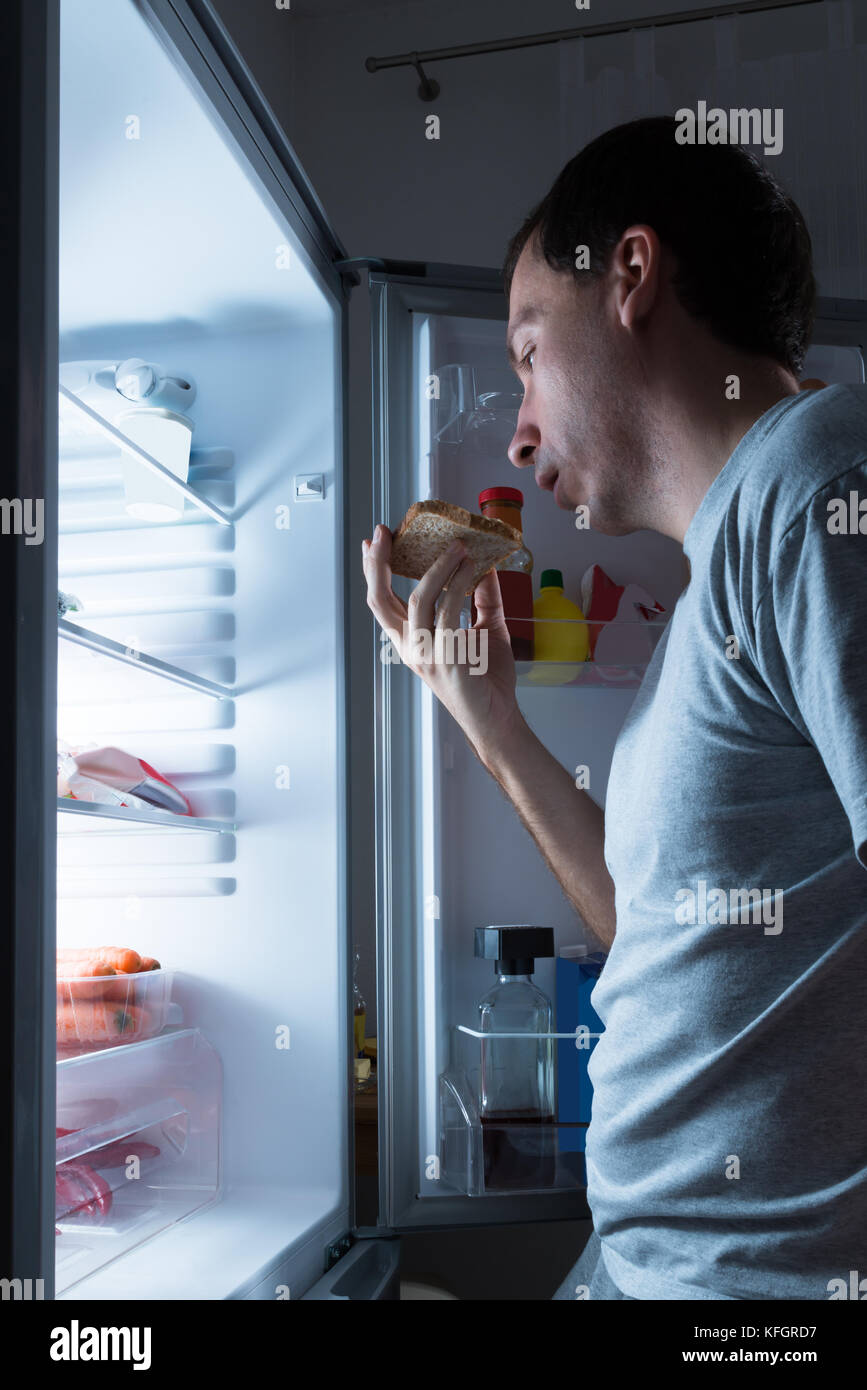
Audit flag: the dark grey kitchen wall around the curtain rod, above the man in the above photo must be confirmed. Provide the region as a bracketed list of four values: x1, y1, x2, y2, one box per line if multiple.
[209, 0, 867, 279]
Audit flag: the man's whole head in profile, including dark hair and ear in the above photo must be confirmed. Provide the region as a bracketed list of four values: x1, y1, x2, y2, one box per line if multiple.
[504, 117, 816, 534]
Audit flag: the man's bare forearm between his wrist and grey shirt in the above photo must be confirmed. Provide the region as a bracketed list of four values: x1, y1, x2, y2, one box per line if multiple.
[468, 719, 616, 951]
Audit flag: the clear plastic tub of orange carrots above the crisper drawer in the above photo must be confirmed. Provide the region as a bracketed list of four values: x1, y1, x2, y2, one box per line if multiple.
[57, 970, 174, 1058]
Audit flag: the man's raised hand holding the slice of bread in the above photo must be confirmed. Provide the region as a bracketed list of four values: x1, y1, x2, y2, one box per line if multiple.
[361, 525, 522, 756]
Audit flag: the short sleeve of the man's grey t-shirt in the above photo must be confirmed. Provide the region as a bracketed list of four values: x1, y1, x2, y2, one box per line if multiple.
[754, 463, 867, 869]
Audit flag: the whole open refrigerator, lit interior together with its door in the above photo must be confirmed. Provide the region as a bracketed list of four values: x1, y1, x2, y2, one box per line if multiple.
[0, 0, 867, 1300]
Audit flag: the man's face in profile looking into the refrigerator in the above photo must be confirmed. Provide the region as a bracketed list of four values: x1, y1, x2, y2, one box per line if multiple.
[507, 230, 650, 535]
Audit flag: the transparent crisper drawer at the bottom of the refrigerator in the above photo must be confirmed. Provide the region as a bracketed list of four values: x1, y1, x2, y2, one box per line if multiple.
[54, 1029, 222, 1294]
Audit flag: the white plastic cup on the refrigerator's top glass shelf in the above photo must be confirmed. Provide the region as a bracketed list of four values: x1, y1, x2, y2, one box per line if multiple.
[115, 406, 193, 523]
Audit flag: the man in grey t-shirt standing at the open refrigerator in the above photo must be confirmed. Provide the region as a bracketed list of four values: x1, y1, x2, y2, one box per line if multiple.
[364, 118, 867, 1300]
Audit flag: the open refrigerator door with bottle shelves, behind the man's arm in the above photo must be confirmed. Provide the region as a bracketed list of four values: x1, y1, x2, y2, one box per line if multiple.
[371, 265, 867, 1230]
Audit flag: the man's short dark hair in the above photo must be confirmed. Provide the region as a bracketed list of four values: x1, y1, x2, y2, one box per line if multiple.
[503, 115, 816, 374]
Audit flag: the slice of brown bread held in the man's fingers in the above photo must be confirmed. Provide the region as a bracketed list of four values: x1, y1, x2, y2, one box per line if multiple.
[390, 500, 524, 594]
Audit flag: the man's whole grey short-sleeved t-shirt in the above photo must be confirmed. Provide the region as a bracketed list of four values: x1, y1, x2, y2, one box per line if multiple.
[586, 386, 867, 1300]
